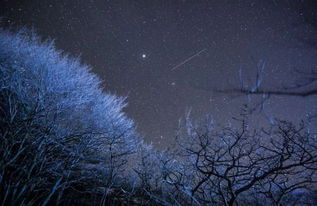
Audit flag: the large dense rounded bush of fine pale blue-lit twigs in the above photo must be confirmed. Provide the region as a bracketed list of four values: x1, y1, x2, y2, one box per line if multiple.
[0, 30, 137, 205]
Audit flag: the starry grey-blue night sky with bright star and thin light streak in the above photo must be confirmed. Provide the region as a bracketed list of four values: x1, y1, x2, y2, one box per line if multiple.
[0, 0, 317, 146]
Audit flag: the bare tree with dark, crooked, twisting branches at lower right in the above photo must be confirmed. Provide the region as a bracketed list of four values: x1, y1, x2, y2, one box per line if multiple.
[173, 108, 317, 206]
